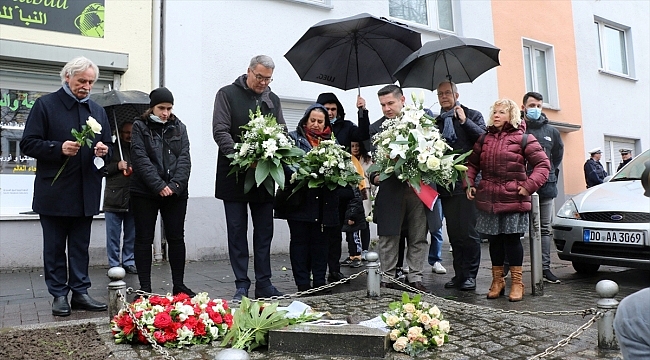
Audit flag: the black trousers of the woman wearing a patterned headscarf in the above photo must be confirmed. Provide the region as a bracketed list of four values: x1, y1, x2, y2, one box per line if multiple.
[287, 220, 330, 287]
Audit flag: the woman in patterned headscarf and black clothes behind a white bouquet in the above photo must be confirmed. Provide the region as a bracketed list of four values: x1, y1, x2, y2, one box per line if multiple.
[275, 104, 353, 291]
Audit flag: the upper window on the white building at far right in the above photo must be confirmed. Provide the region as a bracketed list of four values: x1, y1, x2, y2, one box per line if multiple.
[594, 20, 630, 76]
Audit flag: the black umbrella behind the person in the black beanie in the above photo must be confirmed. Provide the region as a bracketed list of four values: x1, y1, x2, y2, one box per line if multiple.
[90, 90, 149, 165]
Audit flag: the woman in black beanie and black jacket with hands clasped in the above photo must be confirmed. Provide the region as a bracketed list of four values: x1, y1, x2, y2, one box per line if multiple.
[131, 87, 195, 296]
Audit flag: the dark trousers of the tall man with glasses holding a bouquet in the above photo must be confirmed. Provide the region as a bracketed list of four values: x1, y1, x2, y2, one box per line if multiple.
[223, 201, 273, 289]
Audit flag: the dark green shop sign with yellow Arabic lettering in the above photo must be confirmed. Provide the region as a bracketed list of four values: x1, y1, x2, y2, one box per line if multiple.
[0, 0, 104, 38]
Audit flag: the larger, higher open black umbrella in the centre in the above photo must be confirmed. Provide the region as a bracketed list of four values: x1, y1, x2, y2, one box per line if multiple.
[284, 13, 422, 93]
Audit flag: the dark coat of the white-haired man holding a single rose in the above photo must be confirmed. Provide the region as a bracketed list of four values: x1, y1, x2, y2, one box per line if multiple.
[20, 88, 113, 216]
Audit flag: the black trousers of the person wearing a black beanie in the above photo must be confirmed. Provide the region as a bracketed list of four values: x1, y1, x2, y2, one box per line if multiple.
[131, 194, 187, 291]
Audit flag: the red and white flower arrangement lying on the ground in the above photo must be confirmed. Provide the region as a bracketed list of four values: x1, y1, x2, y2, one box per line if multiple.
[111, 293, 233, 348]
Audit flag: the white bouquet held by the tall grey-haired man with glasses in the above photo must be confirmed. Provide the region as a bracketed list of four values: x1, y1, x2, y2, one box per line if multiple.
[226, 107, 305, 195]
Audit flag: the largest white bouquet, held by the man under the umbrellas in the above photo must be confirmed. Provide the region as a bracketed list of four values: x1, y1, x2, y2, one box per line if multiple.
[368, 94, 471, 192]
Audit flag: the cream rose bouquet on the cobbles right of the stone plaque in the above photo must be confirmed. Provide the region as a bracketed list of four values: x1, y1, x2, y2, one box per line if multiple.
[381, 293, 450, 356]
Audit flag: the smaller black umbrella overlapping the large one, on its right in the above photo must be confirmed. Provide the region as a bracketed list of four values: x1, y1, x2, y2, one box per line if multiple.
[394, 36, 500, 90]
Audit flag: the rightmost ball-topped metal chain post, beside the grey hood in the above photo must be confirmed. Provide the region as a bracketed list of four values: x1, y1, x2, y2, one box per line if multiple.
[596, 280, 618, 349]
